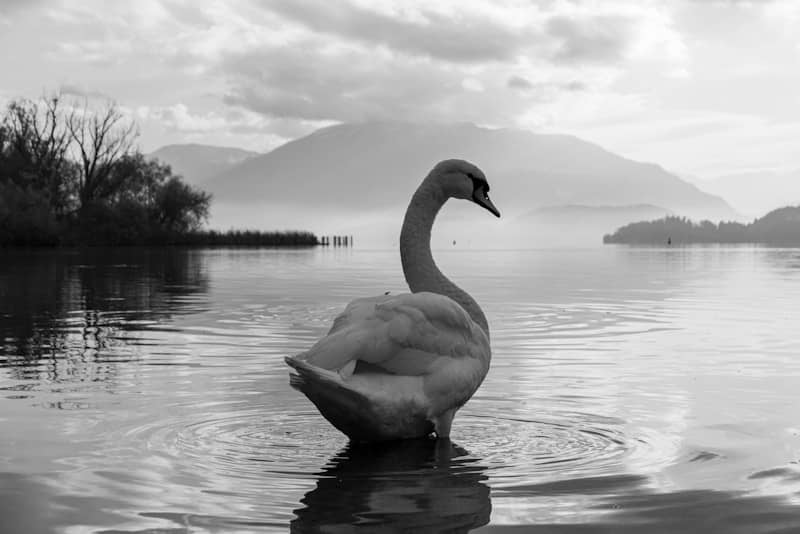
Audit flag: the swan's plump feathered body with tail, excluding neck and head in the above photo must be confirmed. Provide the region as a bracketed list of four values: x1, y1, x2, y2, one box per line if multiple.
[286, 292, 491, 440]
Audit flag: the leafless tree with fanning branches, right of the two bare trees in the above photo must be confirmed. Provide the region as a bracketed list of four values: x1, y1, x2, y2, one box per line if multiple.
[66, 100, 139, 210]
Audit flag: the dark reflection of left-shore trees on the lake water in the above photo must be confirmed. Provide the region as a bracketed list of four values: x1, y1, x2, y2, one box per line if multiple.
[0, 249, 208, 380]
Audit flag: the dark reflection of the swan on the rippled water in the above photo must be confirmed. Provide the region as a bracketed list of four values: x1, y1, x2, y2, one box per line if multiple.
[291, 439, 492, 532]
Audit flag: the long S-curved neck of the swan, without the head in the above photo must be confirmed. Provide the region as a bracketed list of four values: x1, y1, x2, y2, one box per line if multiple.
[400, 177, 489, 336]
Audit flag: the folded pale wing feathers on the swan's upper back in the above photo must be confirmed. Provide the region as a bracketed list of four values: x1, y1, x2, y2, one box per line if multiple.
[301, 292, 489, 376]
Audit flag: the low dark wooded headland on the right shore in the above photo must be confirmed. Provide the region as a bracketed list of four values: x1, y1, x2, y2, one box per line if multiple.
[603, 206, 800, 246]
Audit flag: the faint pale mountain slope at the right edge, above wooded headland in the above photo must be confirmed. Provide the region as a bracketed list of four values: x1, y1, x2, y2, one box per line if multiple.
[695, 169, 800, 217]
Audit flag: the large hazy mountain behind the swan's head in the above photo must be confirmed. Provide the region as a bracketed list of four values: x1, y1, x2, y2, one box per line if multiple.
[206, 122, 737, 225]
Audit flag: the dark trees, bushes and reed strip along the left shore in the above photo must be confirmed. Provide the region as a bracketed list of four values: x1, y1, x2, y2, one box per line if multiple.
[0, 94, 320, 247]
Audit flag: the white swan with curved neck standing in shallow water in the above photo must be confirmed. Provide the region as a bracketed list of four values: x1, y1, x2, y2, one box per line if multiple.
[286, 159, 500, 442]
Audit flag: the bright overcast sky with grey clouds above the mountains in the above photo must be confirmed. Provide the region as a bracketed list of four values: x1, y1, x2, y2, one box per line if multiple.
[0, 0, 800, 178]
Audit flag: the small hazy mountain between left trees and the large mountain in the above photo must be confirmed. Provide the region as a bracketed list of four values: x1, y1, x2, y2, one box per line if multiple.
[147, 144, 260, 185]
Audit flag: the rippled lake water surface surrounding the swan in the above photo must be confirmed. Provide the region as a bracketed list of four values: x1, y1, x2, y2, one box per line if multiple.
[0, 247, 800, 534]
